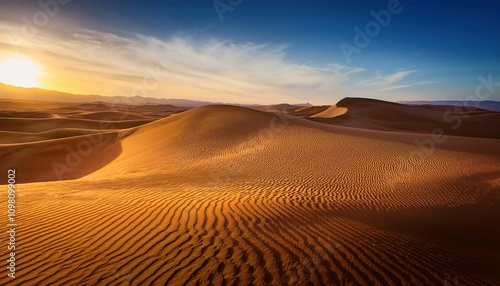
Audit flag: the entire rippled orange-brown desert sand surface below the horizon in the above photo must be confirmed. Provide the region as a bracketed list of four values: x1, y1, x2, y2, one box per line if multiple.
[0, 102, 500, 285]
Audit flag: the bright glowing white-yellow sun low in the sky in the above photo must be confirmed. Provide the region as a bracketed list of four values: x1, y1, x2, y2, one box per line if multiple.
[0, 57, 42, 87]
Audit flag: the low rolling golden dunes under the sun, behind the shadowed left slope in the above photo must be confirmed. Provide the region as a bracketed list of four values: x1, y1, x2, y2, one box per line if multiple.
[0, 101, 160, 145]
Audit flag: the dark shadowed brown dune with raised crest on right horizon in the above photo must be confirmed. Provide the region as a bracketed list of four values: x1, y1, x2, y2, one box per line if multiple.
[311, 98, 500, 139]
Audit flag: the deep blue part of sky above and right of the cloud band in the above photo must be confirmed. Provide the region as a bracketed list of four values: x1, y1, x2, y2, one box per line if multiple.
[0, 0, 500, 103]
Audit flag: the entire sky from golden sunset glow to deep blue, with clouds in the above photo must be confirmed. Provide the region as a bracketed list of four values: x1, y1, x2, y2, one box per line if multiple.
[0, 0, 500, 104]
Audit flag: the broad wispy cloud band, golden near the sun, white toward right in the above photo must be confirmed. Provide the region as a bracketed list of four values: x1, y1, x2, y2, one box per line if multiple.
[0, 16, 430, 103]
